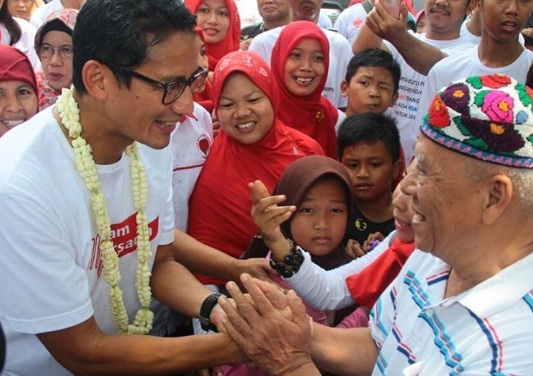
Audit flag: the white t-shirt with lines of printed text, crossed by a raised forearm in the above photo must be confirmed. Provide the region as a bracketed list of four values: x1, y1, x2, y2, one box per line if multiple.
[383, 33, 472, 161]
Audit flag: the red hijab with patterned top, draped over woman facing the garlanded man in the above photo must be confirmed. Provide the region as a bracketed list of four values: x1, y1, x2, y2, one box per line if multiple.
[188, 51, 323, 285]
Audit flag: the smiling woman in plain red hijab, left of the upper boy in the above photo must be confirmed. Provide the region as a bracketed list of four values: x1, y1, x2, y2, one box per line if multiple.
[271, 21, 342, 159]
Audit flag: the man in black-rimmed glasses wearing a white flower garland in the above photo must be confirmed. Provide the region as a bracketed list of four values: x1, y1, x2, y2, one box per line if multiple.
[0, 0, 251, 376]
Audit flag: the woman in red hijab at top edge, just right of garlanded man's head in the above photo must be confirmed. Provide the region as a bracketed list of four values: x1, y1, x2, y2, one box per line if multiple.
[185, 0, 241, 113]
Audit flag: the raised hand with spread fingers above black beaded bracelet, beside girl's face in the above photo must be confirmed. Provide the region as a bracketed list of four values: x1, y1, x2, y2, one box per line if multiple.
[248, 180, 296, 246]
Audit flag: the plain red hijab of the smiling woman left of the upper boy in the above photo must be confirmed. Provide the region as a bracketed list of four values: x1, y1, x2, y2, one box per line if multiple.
[271, 21, 339, 159]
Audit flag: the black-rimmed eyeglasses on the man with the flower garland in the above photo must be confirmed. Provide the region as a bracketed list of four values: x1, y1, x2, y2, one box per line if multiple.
[117, 67, 209, 105]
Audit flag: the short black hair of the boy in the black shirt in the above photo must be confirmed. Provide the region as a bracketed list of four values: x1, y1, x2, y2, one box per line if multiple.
[337, 112, 401, 162]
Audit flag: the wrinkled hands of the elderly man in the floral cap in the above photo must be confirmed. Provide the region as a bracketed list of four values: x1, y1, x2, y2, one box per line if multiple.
[219, 274, 312, 375]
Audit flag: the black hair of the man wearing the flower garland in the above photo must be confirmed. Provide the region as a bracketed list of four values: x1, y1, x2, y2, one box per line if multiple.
[72, 0, 196, 93]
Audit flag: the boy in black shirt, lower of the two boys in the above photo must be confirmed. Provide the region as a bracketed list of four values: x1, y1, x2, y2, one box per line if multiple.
[337, 112, 402, 256]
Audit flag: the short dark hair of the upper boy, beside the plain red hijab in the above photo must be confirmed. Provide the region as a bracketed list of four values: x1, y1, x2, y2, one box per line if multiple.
[345, 48, 402, 93]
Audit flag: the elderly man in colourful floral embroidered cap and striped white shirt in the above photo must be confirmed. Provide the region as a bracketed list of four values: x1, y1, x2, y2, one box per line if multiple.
[221, 75, 533, 376]
